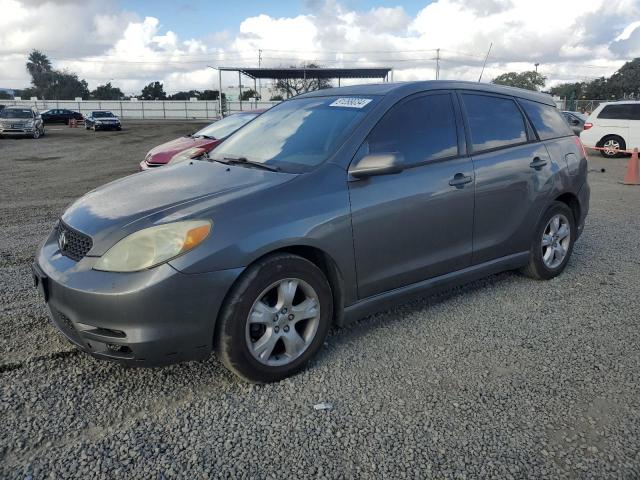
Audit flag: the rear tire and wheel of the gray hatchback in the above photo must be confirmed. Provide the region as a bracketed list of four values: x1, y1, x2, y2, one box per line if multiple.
[520, 202, 577, 280]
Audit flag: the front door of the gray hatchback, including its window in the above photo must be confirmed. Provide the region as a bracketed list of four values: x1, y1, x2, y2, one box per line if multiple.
[349, 91, 473, 298]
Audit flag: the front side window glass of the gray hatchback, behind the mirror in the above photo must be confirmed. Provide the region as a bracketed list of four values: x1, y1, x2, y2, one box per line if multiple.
[361, 93, 458, 166]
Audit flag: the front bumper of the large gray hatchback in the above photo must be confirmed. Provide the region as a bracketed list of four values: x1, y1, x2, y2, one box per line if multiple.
[34, 231, 241, 366]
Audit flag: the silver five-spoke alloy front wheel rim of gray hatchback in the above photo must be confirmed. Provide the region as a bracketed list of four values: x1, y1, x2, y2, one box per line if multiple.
[245, 278, 320, 366]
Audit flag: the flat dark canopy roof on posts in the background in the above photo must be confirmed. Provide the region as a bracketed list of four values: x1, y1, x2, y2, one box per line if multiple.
[219, 67, 392, 80]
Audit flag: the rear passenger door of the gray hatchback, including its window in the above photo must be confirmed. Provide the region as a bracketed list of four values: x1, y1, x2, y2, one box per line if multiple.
[460, 92, 557, 264]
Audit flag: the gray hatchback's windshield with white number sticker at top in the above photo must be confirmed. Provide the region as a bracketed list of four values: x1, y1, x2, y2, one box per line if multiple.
[213, 96, 376, 173]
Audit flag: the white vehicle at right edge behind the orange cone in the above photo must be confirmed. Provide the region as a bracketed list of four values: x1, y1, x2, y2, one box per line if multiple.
[580, 101, 640, 157]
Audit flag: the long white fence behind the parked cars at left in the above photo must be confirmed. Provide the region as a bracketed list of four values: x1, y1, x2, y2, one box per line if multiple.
[2, 100, 278, 120]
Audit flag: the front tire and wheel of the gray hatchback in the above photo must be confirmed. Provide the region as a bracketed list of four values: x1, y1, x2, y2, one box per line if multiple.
[214, 254, 333, 383]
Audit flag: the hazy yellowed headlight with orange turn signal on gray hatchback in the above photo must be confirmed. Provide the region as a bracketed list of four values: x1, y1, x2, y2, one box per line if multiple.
[93, 220, 212, 272]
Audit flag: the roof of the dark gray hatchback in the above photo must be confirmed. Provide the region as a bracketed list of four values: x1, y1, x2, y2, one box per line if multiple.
[296, 80, 555, 106]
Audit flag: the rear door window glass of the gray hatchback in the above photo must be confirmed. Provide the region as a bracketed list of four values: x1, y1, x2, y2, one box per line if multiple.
[462, 93, 527, 152]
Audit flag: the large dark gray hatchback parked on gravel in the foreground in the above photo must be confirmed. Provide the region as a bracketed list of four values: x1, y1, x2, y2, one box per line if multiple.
[34, 81, 590, 382]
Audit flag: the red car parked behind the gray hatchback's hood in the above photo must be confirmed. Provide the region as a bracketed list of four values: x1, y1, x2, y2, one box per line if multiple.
[140, 109, 265, 170]
